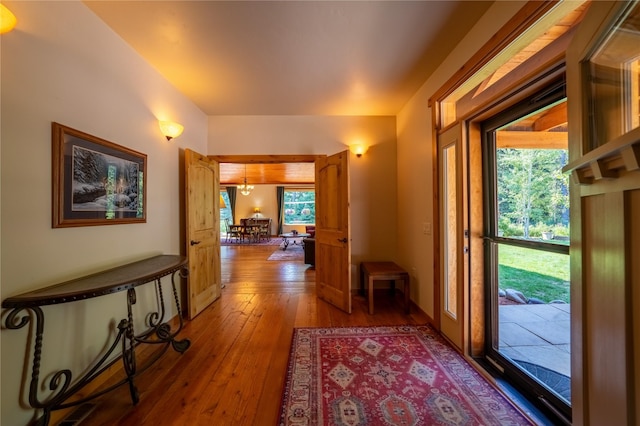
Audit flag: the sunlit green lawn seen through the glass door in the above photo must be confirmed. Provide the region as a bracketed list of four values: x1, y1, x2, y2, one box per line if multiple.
[498, 244, 569, 303]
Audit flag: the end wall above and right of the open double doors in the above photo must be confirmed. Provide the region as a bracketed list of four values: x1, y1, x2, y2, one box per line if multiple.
[208, 116, 397, 287]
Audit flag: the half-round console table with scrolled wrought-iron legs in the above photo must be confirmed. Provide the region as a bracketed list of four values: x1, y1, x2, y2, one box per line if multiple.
[2, 255, 191, 425]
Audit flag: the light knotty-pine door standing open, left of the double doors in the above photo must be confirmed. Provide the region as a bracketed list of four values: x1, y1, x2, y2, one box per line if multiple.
[184, 149, 222, 319]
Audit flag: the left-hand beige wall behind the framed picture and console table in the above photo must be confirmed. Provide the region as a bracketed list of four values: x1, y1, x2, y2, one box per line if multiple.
[0, 1, 207, 425]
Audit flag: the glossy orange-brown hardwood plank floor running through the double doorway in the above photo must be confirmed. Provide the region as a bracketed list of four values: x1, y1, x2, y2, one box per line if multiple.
[83, 246, 427, 426]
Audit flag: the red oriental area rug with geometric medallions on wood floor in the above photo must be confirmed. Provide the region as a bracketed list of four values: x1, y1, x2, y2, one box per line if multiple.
[280, 326, 533, 426]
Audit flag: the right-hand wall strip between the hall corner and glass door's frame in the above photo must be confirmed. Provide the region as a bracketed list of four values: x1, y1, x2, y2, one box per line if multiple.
[397, 1, 526, 316]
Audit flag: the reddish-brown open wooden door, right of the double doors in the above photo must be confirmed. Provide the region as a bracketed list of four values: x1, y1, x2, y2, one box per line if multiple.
[316, 151, 351, 313]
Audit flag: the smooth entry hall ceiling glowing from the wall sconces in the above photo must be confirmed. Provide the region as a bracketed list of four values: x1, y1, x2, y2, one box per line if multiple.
[84, 0, 493, 115]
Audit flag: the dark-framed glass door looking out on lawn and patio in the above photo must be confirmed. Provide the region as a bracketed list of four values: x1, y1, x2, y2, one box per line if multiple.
[481, 80, 571, 421]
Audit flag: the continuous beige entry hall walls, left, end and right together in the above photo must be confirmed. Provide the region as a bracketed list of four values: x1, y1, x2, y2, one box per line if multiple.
[0, 1, 524, 425]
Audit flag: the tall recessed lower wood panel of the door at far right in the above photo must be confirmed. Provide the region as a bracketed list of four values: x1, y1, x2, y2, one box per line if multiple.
[582, 192, 631, 424]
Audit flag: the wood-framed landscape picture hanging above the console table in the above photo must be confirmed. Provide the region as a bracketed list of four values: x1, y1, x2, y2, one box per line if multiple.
[51, 122, 147, 228]
